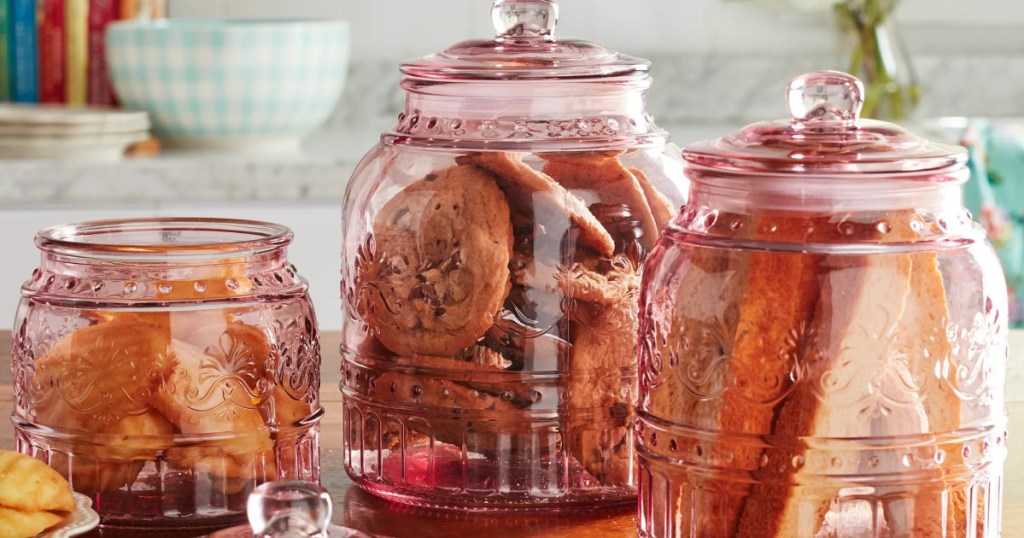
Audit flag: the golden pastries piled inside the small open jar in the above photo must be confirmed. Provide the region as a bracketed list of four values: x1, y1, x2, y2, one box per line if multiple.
[28, 258, 317, 494]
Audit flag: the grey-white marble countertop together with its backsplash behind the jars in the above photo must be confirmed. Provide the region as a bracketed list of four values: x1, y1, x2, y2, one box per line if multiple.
[8, 46, 1024, 208]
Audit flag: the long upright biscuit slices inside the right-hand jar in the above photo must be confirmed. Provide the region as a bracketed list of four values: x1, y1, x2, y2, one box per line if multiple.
[641, 210, 971, 536]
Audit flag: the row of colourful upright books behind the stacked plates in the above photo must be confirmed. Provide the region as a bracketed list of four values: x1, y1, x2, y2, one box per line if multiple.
[0, 0, 166, 107]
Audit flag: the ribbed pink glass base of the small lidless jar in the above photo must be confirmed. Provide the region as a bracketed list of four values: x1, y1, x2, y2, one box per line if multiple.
[12, 413, 322, 536]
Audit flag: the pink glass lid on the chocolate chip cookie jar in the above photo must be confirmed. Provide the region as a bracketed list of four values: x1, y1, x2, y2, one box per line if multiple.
[401, 0, 650, 80]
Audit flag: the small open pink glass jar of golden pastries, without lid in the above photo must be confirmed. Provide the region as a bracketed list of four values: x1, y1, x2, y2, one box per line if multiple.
[11, 218, 323, 535]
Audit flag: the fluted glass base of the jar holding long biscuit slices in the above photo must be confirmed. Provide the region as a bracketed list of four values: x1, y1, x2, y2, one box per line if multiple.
[637, 428, 1002, 538]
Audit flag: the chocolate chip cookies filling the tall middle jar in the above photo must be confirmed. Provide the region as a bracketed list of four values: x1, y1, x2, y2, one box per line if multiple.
[347, 147, 675, 486]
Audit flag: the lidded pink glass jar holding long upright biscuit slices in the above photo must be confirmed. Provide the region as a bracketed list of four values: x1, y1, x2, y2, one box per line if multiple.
[637, 72, 1007, 537]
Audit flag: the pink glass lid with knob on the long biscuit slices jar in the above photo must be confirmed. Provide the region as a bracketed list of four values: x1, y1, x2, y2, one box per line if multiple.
[683, 71, 967, 175]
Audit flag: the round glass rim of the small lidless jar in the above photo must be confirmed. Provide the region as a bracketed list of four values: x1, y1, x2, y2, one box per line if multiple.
[36, 217, 294, 259]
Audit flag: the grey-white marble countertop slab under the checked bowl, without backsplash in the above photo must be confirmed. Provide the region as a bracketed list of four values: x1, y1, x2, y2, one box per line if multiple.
[0, 118, 738, 208]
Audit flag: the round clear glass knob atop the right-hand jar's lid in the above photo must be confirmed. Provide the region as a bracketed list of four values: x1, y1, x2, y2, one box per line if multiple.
[786, 71, 864, 129]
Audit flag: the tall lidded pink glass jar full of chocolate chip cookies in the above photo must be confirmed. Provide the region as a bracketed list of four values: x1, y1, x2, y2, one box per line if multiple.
[341, 0, 683, 509]
